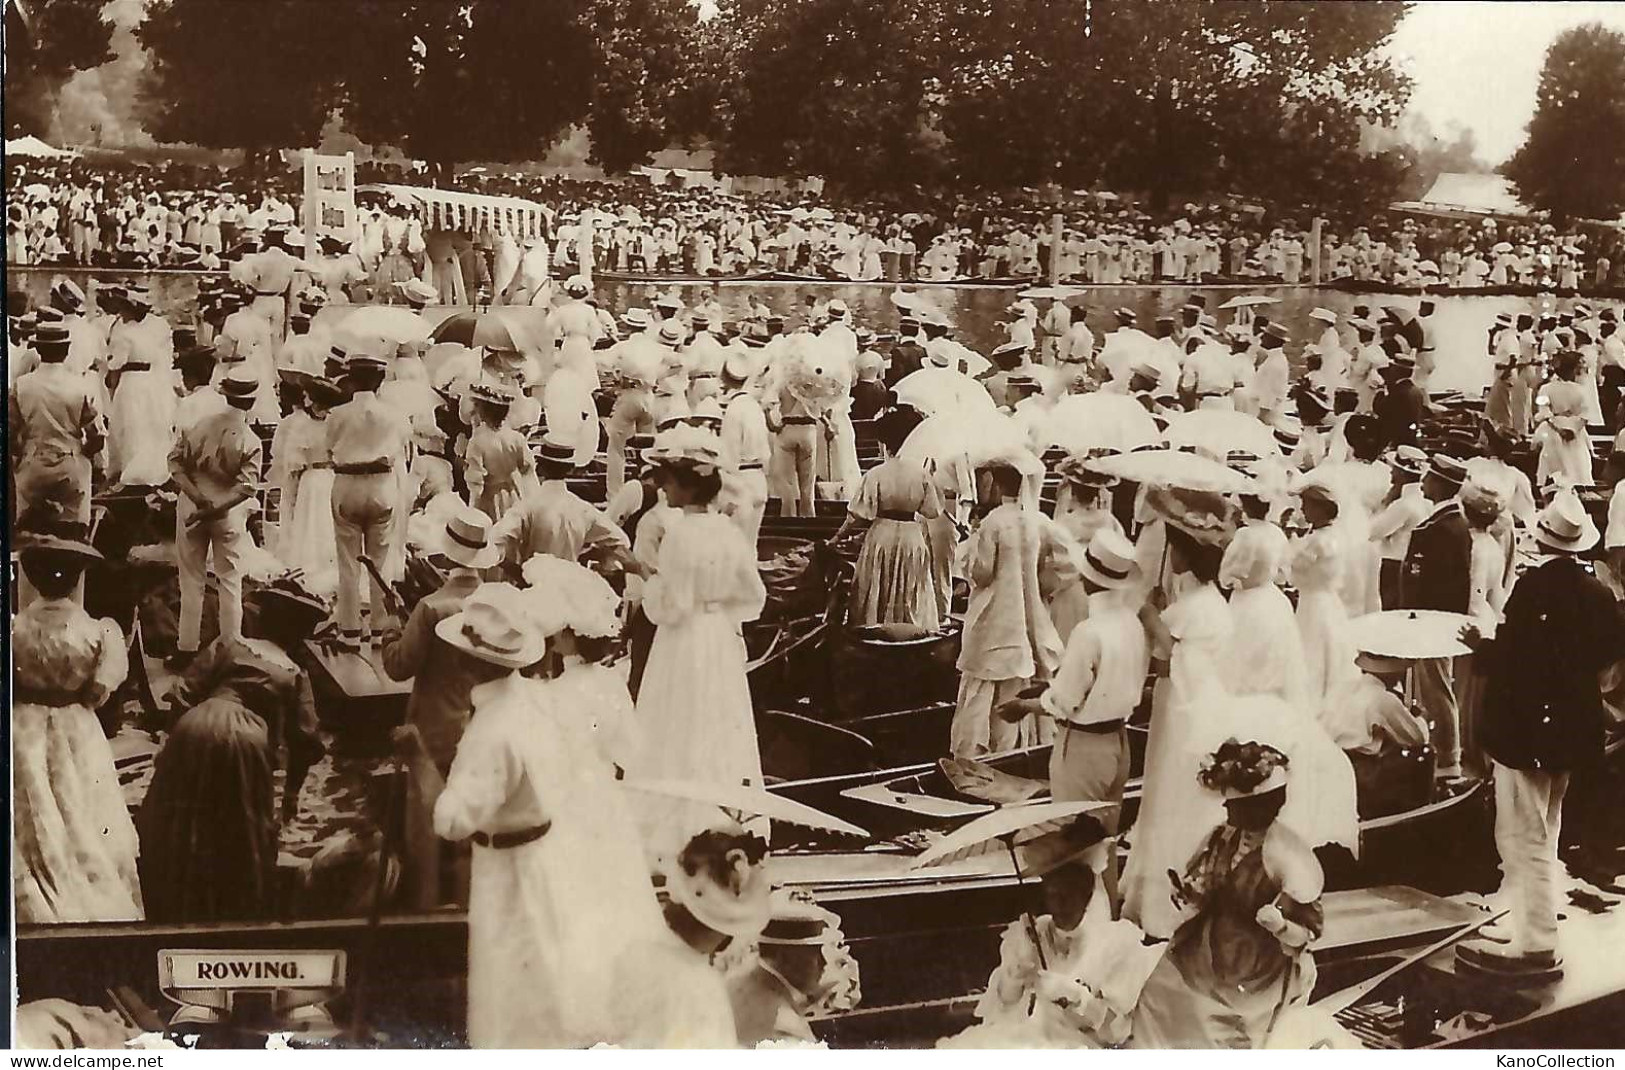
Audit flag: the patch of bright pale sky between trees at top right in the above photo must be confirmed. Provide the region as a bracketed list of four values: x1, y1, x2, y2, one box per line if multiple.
[1389, 0, 1625, 164]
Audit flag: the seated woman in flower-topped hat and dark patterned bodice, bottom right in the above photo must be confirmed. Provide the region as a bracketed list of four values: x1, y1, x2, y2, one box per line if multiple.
[1133, 740, 1324, 1049]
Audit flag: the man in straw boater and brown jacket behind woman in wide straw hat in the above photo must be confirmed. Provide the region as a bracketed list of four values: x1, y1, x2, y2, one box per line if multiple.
[380, 509, 502, 911]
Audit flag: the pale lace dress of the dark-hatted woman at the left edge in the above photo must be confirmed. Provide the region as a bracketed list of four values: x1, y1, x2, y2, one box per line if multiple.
[11, 598, 141, 925]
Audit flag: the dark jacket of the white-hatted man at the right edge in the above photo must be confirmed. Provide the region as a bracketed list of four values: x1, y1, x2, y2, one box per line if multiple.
[1472, 558, 1625, 772]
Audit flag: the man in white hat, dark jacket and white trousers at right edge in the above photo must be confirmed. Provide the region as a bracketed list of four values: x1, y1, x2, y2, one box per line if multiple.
[1458, 489, 1625, 984]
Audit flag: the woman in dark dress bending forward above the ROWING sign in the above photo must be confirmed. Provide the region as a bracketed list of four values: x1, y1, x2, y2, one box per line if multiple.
[137, 579, 327, 922]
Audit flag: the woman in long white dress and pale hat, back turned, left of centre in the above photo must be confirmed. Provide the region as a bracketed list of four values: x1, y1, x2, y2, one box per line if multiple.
[637, 426, 767, 854]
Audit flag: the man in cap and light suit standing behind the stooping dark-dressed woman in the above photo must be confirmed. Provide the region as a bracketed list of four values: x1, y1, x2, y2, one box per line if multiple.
[169, 368, 262, 662]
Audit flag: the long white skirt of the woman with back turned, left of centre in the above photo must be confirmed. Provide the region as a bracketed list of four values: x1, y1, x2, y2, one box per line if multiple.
[637, 613, 762, 855]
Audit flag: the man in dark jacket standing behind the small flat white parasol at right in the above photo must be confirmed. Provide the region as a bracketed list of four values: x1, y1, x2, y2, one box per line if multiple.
[1399, 454, 1472, 777]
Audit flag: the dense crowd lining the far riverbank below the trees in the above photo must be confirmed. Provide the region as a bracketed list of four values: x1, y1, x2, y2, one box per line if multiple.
[7, 152, 1625, 289]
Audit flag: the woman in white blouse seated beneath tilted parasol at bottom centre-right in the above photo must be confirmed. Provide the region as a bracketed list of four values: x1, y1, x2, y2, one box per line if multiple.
[939, 813, 1164, 1047]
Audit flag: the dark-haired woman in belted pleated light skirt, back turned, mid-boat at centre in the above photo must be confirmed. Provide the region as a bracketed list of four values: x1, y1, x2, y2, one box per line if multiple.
[837, 408, 943, 633]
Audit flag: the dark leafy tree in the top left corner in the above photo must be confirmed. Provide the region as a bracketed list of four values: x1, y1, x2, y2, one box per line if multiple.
[5, 0, 112, 137]
